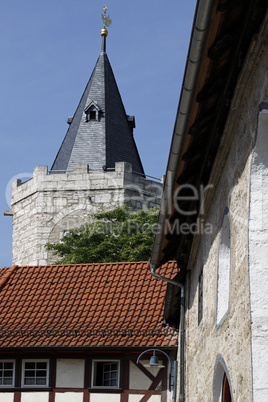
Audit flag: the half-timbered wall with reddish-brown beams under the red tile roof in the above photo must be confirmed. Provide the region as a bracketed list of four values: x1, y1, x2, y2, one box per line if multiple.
[0, 354, 174, 402]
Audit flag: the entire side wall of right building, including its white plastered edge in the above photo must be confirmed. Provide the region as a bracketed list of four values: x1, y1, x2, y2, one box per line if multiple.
[182, 19, 268, 402]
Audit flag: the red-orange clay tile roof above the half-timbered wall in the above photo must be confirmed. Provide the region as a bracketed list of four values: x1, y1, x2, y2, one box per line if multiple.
[0, 262, 177, 348]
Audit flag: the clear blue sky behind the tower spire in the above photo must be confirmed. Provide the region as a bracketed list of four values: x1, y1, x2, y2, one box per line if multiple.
[0, 0, 196, 267]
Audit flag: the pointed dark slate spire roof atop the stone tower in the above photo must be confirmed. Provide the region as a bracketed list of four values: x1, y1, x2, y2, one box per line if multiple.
[51, 32, 144, 174]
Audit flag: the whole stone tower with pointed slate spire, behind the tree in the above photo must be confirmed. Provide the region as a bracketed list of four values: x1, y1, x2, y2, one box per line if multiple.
[11, 17, 161, 265]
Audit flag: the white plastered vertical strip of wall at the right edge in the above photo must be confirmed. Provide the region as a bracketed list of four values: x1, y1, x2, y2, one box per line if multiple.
[249, 110, 268, 401]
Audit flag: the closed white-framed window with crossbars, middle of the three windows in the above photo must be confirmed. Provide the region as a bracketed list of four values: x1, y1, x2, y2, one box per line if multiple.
[22, 359, 49, 387]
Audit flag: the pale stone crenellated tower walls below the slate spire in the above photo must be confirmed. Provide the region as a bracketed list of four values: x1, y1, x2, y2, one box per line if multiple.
[11, 162, 162, 265]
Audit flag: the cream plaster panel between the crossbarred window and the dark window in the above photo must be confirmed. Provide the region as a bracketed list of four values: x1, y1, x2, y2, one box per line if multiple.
[56, 359, 85, 388]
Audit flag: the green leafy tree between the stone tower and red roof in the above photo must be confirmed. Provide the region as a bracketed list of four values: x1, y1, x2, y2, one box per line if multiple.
[47, 206, 159, 264]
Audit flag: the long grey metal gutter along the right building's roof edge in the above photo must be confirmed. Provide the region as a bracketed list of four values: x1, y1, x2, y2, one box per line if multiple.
[150, 0, 214, 269]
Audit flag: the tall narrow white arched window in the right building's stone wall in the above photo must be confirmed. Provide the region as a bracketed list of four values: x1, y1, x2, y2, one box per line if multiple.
[216, 208, 231, 325]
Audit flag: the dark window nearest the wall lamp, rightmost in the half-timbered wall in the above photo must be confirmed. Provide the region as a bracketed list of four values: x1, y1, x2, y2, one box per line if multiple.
[92, 360, 120, 388]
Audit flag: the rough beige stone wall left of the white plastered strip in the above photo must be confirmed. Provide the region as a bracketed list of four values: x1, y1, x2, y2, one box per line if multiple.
[182, 13, 268, 402]
